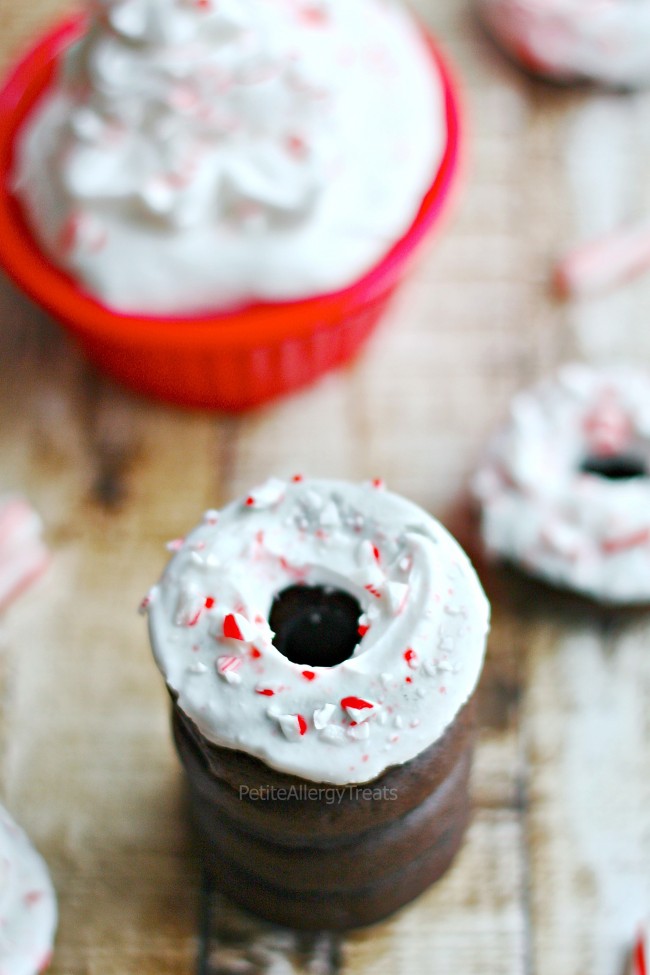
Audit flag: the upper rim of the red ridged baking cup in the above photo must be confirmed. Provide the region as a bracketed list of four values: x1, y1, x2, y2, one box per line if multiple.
[0, 15, 460, 350]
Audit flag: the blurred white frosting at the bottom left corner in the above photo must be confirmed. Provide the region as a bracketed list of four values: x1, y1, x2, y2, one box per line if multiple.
[0, 806, 57, 975]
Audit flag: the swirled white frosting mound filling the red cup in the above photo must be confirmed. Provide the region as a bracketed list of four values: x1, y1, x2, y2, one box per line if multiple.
[14, 0, 446, 315]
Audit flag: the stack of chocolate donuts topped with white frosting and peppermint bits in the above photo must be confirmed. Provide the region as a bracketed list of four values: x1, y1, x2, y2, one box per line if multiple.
[146, 479, 488, 929]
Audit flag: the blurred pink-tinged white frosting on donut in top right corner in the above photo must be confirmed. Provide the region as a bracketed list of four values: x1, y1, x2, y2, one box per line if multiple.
[476, 0, 650, 87]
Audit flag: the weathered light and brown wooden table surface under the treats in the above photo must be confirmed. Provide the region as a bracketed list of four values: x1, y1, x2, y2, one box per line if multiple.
[0, 0, 650, 975]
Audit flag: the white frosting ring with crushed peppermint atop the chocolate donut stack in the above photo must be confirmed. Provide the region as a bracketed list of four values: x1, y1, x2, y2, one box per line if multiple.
[145, 480, 489, 785]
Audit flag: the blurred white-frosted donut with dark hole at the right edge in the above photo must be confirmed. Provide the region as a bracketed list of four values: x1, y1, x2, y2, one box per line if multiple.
[473, 365, 650, 604]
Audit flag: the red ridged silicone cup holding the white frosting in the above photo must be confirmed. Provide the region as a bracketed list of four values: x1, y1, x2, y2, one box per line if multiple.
[0, 16, 460, 411]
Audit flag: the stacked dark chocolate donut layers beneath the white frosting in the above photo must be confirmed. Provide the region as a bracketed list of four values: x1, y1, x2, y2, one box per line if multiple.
[173, 697, 475, 929]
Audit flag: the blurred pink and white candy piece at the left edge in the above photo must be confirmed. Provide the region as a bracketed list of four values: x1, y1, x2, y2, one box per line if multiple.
[0, 497, 50, 610]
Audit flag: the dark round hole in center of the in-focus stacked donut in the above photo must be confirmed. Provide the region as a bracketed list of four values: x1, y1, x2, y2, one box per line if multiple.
[269, 585, 362, 667]
